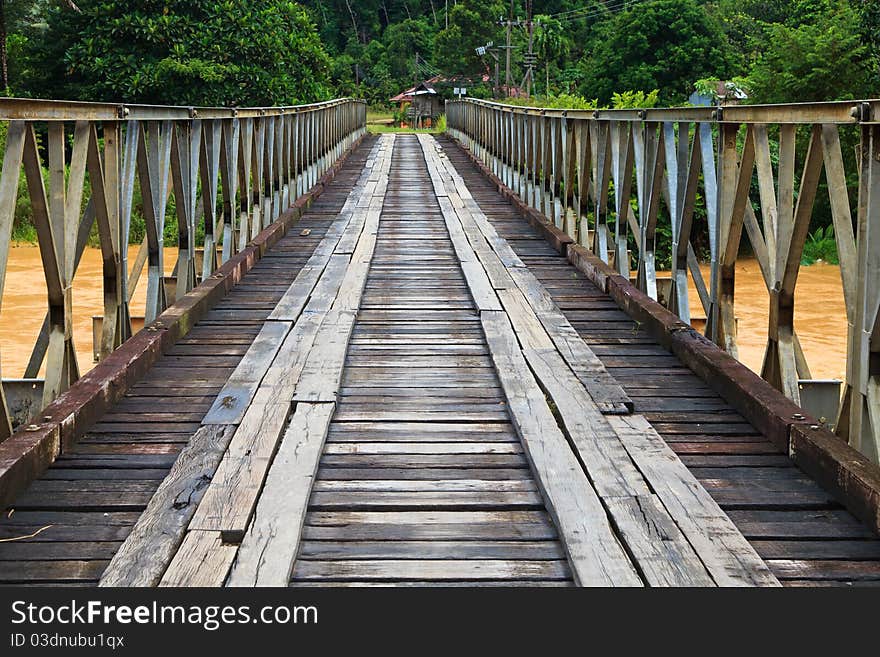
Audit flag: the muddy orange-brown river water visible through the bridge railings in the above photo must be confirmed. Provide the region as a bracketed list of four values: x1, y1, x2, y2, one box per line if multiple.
[0, 246, 846, 379]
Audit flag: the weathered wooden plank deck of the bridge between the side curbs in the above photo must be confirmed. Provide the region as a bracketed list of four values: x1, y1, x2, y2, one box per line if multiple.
[0, 136, 880, 586]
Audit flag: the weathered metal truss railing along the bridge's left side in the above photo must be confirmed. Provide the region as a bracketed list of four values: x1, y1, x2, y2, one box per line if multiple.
[0, 99, 366, 440]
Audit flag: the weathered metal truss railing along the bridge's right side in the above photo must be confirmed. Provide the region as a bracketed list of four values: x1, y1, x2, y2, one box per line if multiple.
[446, 100, 880, 462]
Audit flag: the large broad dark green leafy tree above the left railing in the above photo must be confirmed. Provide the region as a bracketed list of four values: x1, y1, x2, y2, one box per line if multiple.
[27, 0, 331, 105]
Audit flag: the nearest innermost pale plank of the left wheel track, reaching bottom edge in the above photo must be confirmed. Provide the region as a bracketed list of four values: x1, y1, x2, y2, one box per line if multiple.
[229, 403, 334, 586]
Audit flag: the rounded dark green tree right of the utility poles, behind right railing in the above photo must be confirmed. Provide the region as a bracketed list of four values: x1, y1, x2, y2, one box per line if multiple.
[580, 0, 735, 104]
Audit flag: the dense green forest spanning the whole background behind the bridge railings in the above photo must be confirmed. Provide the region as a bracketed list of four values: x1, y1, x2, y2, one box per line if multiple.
[0, 0, 880, 106]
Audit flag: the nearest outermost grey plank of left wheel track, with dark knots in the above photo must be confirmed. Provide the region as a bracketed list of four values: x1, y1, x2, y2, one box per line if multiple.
[99, 425, 235, 586]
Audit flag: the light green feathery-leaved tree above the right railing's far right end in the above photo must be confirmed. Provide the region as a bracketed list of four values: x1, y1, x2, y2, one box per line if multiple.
[747, 2, 878, 103]
